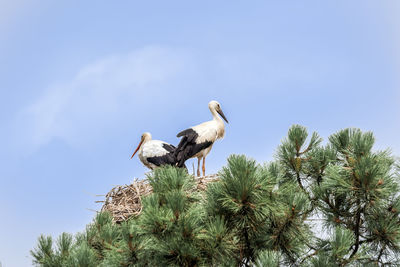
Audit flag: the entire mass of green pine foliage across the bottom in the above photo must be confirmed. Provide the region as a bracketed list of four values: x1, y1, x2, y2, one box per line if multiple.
[31, 125, 400, 267]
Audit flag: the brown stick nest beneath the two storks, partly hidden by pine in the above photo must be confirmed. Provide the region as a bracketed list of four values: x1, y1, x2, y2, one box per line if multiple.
[96, 174, 218, 223]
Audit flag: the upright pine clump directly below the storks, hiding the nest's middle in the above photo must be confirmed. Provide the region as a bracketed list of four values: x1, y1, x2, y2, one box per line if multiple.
[138, 167, 204, 266]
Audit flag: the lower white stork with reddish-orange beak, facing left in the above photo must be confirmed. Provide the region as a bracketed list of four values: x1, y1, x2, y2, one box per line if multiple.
[131, 132, 181, 170]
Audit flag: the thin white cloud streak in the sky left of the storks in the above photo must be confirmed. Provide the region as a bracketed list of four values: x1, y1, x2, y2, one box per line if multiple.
[16, 46, 187, 151]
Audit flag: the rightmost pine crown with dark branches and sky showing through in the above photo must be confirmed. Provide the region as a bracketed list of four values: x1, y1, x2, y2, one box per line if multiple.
[278, 125, 400, 266]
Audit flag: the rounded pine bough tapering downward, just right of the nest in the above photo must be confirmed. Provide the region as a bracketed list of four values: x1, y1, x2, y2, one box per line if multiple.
[207, 156, 272, 264]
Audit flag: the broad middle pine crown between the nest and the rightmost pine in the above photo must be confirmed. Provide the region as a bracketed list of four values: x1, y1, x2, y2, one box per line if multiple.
[207, 156, 311, 266]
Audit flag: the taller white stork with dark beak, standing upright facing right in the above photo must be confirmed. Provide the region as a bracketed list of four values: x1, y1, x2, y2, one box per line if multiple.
[175, 100, 228, 176]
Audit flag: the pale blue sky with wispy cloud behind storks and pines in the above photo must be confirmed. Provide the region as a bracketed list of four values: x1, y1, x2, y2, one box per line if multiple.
[0, 0, 400, 267]
